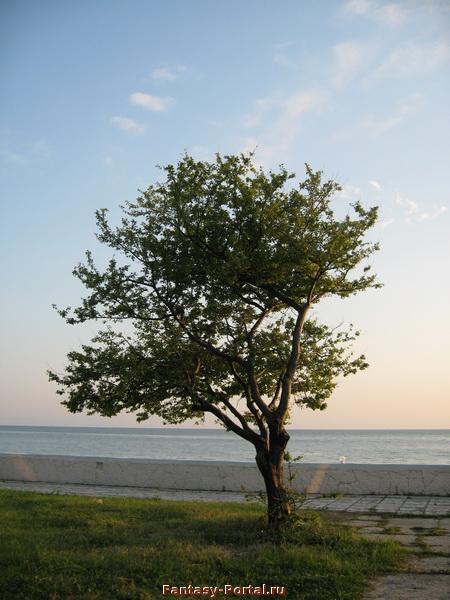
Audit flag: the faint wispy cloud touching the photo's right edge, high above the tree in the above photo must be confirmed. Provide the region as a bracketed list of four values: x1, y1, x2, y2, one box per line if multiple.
[373, 42, 450, 78]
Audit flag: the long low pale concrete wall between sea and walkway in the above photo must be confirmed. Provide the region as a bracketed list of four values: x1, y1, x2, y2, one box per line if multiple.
[0, 454, 450, 496]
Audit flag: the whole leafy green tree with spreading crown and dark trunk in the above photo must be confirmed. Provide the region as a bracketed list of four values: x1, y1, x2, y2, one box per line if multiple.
[49, 155, 379, 523]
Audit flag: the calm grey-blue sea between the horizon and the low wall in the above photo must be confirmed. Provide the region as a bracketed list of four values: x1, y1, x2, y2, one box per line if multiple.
[0, 426, 450, 464]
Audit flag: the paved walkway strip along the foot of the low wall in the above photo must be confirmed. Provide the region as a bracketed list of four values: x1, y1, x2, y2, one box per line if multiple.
[0, 481, 450, 517]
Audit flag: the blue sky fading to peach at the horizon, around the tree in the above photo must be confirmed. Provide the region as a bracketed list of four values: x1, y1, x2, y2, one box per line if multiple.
[0, 0, 450, 429]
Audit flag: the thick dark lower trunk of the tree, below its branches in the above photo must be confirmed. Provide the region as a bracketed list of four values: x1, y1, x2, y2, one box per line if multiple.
[256, 429, 292, 527]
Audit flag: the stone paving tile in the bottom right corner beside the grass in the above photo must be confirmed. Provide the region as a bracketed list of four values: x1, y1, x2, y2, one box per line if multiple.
[363, 573, 450, 600]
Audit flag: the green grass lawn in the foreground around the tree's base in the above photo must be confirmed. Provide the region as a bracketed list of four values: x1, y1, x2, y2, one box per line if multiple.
[0, 491, 404, 600]
